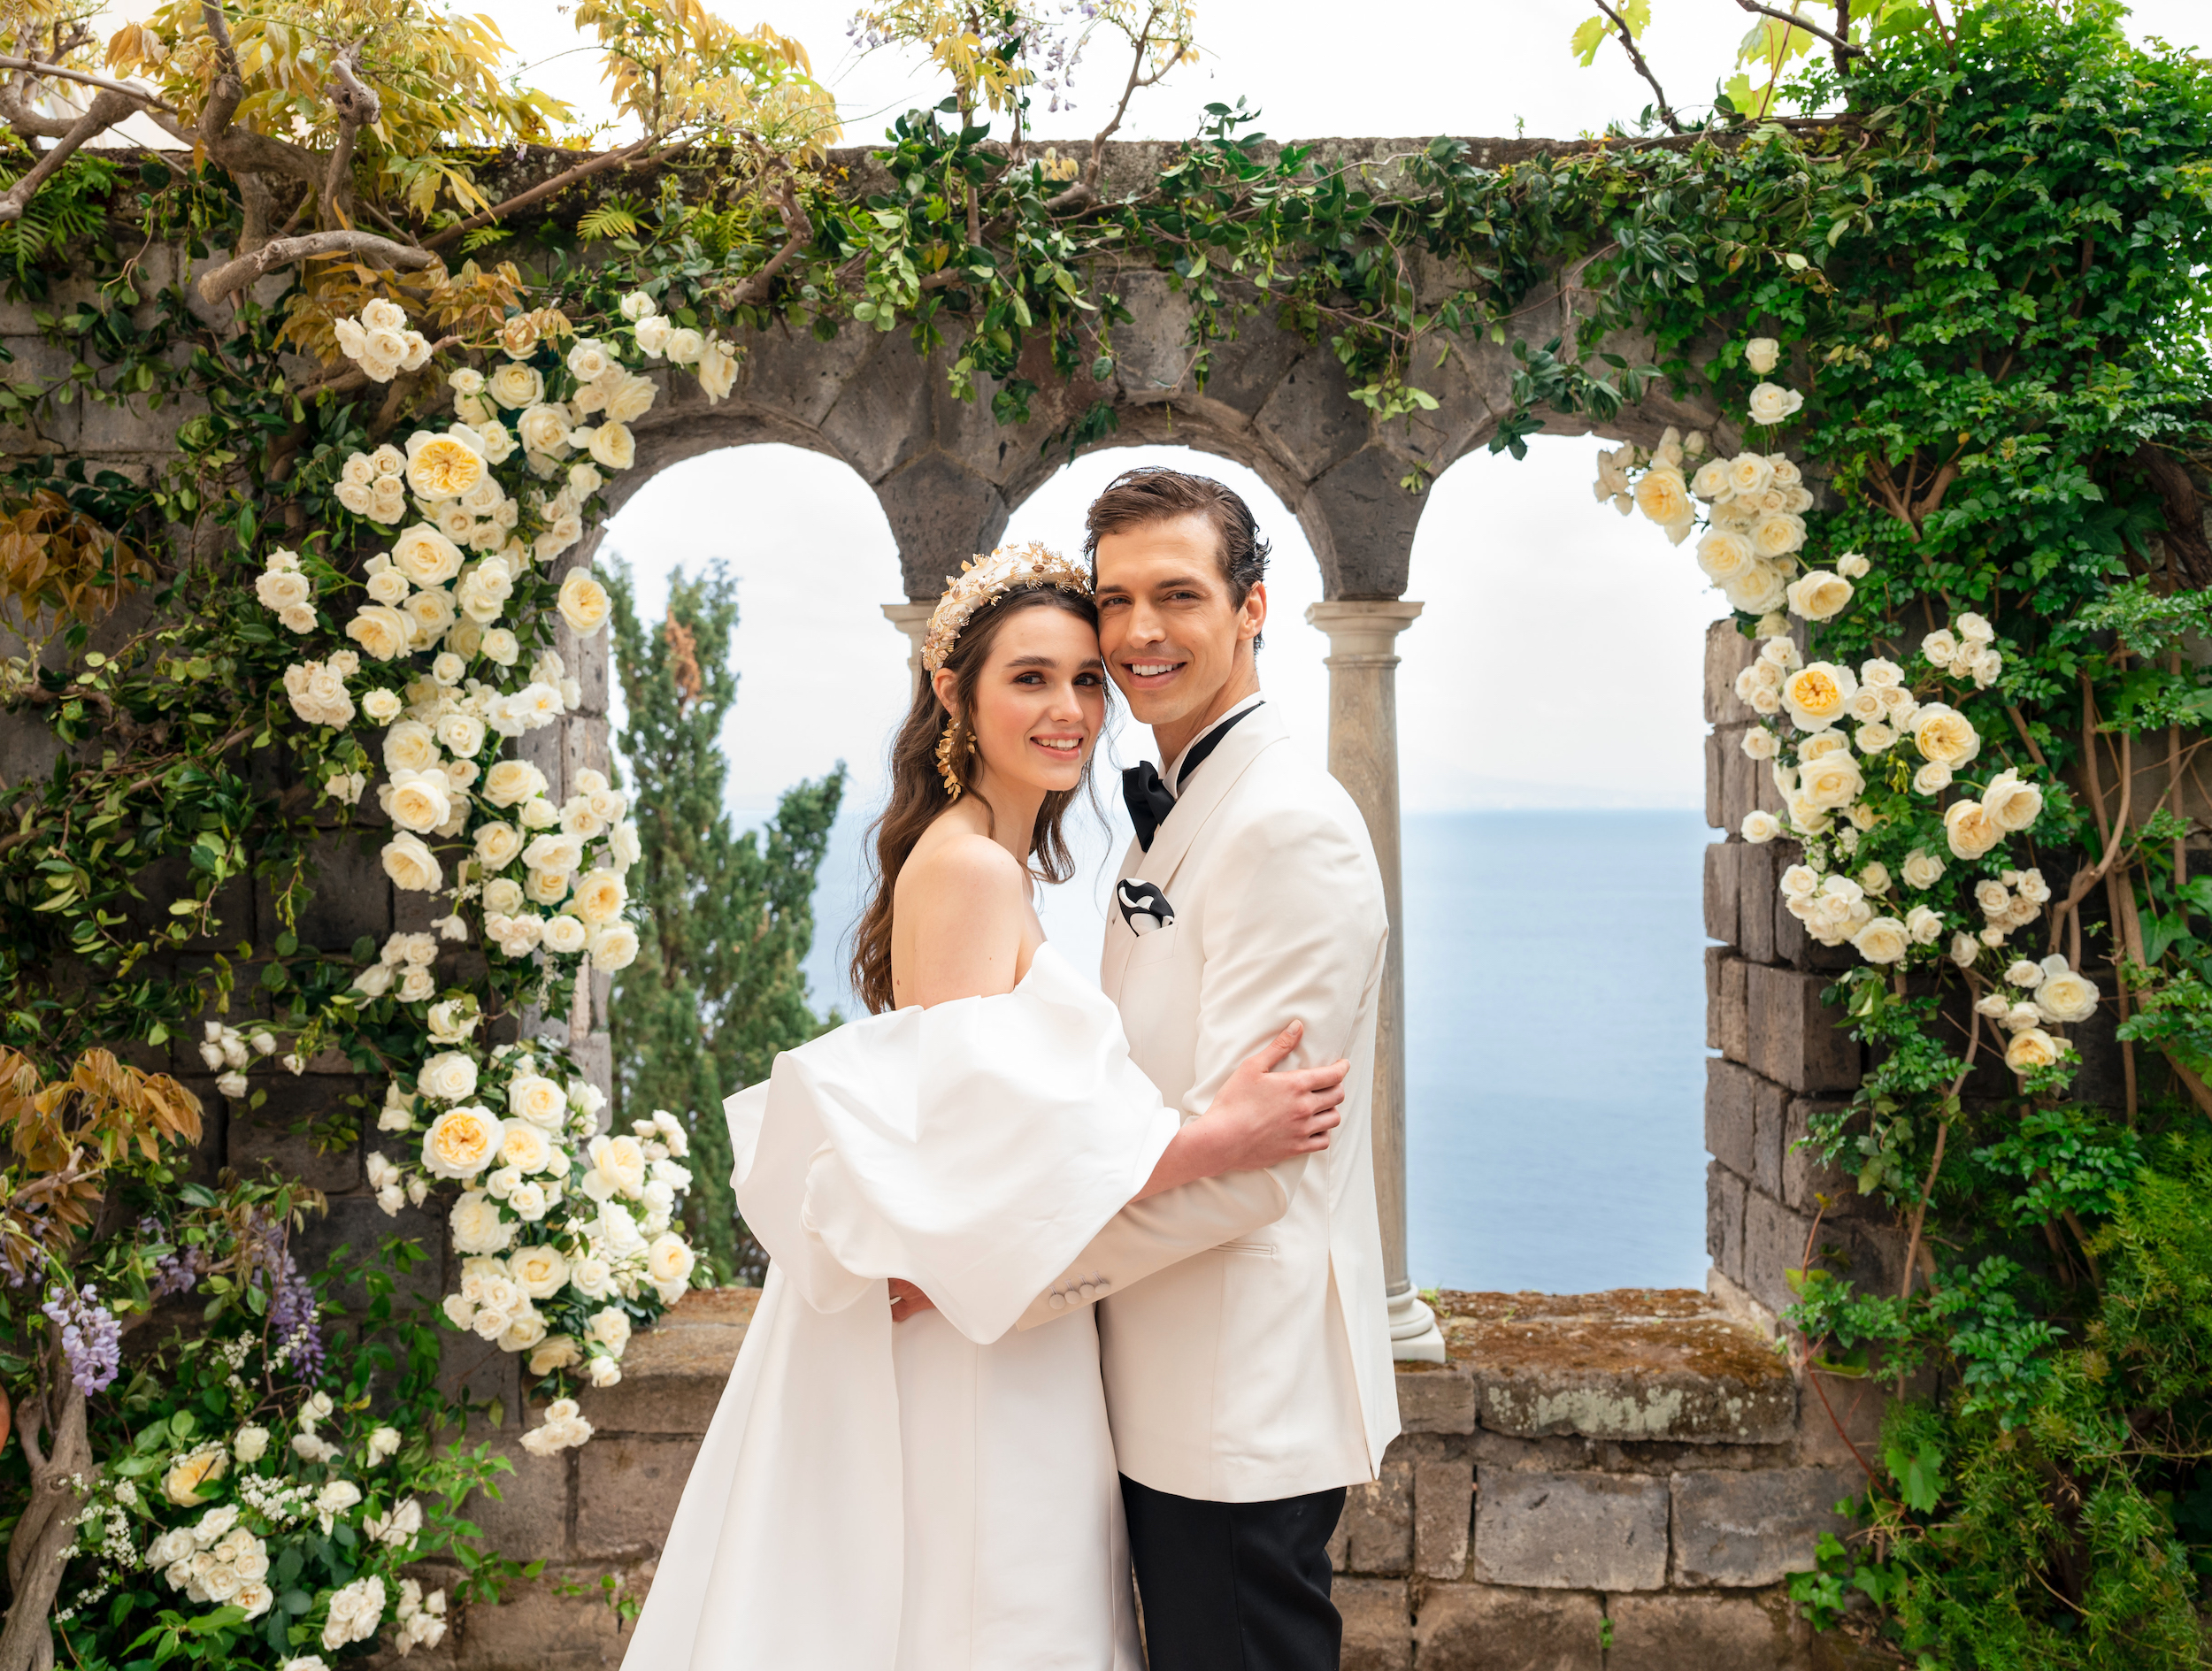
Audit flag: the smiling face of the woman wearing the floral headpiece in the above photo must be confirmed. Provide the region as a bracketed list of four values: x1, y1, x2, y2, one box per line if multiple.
[938, 608, 1106, 792]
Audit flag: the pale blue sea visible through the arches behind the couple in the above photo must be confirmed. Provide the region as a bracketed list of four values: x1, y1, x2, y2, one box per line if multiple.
[755, 807, 1712, 1293]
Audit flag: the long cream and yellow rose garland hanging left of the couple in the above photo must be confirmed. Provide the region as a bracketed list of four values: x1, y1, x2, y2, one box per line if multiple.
[231, 292, 737, 1453]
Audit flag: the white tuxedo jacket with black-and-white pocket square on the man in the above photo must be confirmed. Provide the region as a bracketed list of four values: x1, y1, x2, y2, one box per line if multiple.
[1022, 703, 1398, 1503]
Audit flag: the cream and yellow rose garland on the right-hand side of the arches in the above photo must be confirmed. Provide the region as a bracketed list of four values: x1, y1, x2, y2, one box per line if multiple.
[1595, 336, 2100, 1074]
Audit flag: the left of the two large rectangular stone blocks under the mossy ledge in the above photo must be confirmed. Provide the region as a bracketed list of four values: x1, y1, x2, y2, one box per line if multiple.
[1476, 1466, 1668, 1591]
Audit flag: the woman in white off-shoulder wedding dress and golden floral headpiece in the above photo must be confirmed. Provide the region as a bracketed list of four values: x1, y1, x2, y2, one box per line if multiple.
[624, 546, 1348, 1671]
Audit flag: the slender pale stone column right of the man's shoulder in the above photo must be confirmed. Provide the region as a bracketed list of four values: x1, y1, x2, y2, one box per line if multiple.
[1305, 599, 1445, 1364]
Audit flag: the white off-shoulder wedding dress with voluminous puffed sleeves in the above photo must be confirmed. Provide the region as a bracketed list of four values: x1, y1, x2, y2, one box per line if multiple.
[624, 946, 1179, 1671]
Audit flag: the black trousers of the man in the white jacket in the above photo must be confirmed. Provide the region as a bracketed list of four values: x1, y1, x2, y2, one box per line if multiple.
[1122, 1475, 1345, 1671]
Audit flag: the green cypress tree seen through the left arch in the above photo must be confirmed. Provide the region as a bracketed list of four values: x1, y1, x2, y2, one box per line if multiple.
[609, 562, 845, 1282]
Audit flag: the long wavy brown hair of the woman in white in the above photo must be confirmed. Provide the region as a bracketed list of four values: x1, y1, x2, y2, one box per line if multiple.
[852, 586, 1113, 1015]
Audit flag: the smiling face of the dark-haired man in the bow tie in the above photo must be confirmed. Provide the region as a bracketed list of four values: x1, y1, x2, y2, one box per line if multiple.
[1097, 515, 1268, 749]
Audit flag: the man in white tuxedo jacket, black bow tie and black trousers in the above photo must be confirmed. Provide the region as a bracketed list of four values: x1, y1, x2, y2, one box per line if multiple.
[1022, 469, 1398, 1671]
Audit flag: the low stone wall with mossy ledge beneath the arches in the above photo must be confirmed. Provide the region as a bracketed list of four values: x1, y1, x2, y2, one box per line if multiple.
[380, 1289, 1861, 1671]
